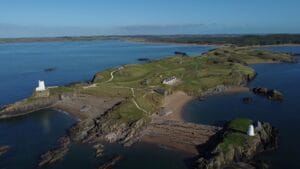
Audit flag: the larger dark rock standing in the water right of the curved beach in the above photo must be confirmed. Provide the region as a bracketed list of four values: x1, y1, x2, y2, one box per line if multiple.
[252, 87, 283, 101]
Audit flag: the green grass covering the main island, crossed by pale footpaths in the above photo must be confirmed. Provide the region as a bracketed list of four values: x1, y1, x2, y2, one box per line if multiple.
[45, 47, 291, 122]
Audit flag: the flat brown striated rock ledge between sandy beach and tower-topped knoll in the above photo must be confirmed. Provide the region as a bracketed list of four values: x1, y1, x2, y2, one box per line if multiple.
[143, 118, 221, 154]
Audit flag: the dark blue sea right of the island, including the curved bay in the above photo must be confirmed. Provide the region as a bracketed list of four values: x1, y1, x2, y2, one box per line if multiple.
[184, 46, 300, 169]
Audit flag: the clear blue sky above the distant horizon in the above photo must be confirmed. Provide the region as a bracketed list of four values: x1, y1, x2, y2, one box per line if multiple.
[0, 0, 300, 37]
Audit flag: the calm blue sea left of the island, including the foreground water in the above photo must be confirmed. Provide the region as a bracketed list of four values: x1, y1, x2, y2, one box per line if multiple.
[0, 41, 211, 169]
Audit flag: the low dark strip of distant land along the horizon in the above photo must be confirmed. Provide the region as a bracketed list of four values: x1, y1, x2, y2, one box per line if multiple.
[0, 34, 300, 46]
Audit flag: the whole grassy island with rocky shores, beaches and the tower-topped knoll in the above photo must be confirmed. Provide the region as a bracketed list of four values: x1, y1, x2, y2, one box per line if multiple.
[0, 45, 296, 168]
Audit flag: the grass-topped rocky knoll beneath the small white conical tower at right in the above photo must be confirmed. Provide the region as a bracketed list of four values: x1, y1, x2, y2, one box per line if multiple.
[197, 119, 278, 169]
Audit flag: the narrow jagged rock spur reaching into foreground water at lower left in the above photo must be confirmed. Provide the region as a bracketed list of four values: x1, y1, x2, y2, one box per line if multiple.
[39, 136, 71, 166]
